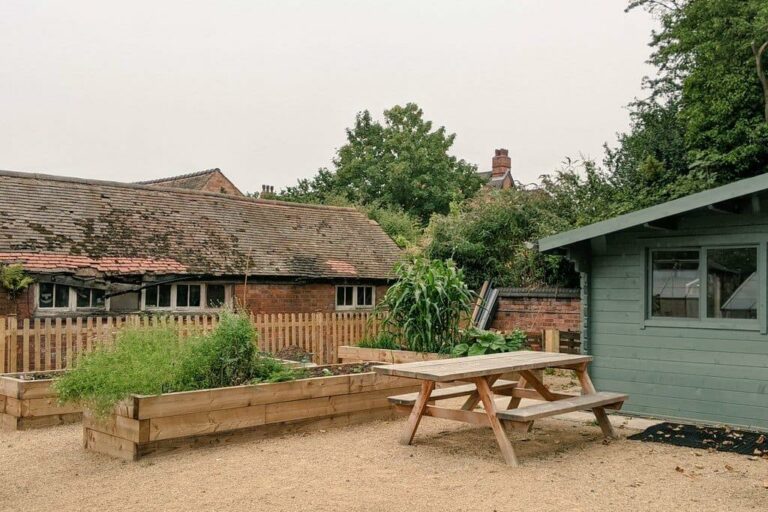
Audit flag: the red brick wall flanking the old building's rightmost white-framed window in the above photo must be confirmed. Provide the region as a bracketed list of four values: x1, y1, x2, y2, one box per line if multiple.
[235, 283, 387, 313]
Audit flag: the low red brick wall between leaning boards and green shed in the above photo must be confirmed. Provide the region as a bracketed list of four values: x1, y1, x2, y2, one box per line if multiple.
[490, 289, 581, 331]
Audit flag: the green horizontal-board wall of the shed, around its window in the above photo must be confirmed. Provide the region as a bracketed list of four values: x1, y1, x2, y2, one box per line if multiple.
[587, 210, 768, 429]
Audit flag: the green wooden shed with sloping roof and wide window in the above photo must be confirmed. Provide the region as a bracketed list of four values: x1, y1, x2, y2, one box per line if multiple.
[539, 174, 768, 430]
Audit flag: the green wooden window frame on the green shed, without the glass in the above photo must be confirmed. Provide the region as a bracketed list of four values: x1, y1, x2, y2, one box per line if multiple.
[641, 243, 768, 334]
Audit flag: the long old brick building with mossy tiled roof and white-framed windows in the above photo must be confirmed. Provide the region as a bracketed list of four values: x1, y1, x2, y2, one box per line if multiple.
[0, 170, 401, 318]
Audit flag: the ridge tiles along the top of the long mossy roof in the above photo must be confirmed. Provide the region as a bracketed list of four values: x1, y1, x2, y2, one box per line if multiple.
[0, 169, 364, 215]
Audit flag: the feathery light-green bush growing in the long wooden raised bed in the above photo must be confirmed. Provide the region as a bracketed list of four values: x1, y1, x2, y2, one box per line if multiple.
[55, 312, 299, 416]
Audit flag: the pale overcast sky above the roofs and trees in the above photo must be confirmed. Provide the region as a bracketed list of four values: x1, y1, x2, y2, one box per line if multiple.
[0, 0, 656, 191]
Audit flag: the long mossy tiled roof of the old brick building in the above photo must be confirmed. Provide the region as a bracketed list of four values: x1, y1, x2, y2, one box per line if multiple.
[0, 171, 401, 279]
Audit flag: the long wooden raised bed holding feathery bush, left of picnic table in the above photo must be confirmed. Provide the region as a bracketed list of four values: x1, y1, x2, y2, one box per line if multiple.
[83, 364, 419, 460]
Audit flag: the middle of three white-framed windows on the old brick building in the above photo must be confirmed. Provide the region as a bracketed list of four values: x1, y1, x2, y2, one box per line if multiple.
[141, 283, 232, 311]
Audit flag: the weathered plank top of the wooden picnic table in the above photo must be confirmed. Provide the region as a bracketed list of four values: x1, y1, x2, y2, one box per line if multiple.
[373, 350, 592, 382]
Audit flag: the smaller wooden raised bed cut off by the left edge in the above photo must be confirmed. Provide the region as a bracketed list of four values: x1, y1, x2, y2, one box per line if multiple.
[0, 371, 82, 430]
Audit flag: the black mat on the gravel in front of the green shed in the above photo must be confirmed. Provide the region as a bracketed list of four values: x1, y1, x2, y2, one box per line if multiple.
[627, 423, 768, 458]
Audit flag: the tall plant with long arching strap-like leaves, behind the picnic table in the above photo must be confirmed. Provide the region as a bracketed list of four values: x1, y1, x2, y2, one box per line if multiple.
[377, 258, 474, 353]
